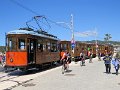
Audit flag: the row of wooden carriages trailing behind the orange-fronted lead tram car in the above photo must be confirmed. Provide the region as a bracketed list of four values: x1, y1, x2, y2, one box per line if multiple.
[60, 41, 114, 60]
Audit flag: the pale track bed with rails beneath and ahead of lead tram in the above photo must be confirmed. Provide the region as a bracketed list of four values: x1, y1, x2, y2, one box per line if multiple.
[0, 65, 62, 90]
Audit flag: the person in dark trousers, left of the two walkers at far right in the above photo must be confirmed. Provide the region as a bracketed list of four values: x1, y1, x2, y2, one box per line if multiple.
[103, 54, 112, 73]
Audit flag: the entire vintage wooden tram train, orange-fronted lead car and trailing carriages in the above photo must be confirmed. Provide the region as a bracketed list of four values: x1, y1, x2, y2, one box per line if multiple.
[5, 28, 114, 70]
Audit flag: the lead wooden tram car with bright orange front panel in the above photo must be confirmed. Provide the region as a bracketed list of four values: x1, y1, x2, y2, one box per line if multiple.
[6, 28, 60, 70]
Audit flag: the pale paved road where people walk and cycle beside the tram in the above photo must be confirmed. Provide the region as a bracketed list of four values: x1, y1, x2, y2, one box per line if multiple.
[0, 58, 120, 90]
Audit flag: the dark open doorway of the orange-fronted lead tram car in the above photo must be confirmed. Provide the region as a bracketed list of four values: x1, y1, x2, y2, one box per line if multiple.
[28, 39, 36, 64]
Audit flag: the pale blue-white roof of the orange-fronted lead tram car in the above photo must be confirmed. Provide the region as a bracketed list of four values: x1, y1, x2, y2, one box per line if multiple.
[7, 30, 60, 40]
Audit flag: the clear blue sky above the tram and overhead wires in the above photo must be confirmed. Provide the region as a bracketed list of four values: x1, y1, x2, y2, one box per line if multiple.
[0, 0, 120, 46]
